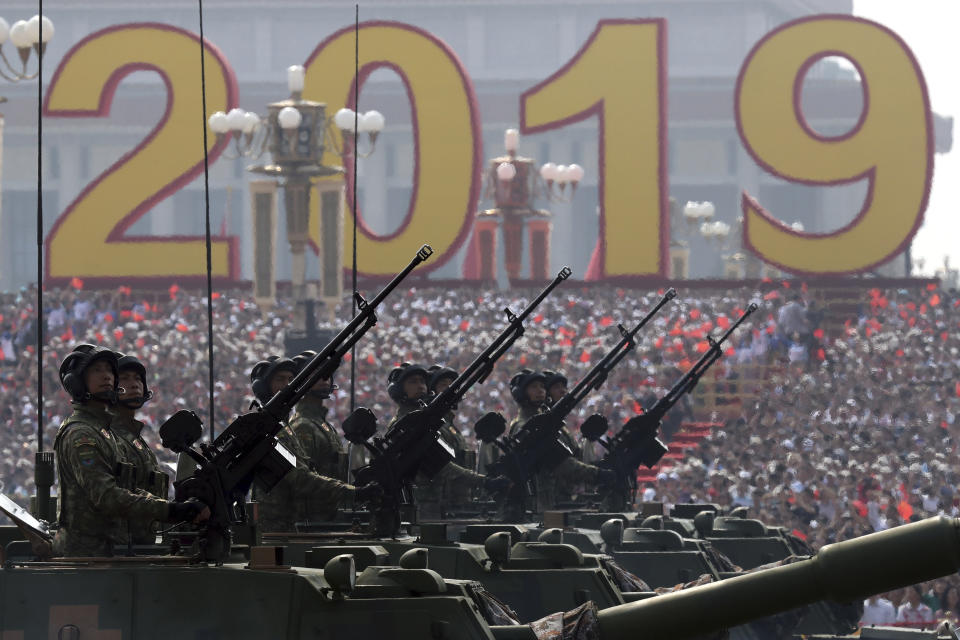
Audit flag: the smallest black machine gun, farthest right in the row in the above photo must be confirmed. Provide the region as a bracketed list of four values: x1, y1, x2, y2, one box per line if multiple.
[581, 302, 757, 510]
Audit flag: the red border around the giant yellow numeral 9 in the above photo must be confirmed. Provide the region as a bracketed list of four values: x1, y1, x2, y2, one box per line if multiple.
[734, 14, 934, 276]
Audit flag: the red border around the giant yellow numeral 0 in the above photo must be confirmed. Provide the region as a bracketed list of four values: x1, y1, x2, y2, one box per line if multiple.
[303, 20, 483, 278]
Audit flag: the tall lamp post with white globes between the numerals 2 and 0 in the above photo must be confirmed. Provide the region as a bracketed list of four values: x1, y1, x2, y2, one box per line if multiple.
[208, 65, 385, 332]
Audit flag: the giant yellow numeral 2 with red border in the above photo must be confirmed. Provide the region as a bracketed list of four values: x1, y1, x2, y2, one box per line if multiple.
[44, 23, 239, 282]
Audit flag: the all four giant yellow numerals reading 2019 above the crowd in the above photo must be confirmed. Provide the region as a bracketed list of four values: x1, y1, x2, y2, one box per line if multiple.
[46, 16, 933, 280]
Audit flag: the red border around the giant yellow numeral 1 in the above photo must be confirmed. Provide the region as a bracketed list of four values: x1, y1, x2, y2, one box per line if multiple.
[520, 18, 670, 282]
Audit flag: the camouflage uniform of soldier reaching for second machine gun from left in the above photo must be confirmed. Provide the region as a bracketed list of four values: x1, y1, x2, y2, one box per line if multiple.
[253, 425, 354, 533]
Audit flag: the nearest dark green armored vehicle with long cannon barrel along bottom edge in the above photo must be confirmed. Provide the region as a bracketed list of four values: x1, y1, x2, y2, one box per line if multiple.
[0, 517, 960, 640]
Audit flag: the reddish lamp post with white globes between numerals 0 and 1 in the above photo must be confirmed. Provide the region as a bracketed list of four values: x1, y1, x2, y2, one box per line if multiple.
[474, 129, 584, 280]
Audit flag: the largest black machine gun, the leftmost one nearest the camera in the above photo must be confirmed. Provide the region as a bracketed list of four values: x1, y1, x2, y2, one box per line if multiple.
[160, 245, 433, 562]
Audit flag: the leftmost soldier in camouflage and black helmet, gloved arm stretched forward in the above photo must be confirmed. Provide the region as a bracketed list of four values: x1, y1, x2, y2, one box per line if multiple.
[53, 344, 210, 556]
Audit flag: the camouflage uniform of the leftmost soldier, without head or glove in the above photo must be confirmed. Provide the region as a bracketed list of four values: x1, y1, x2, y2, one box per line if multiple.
[53, 405, 169, 556]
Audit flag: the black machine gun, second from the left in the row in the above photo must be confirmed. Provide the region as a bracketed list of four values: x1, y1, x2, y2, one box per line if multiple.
[343, 267, 571, 536]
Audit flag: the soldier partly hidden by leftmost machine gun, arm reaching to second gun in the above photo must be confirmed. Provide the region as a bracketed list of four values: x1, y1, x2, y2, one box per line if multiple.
[250, 356, 380, 533]
